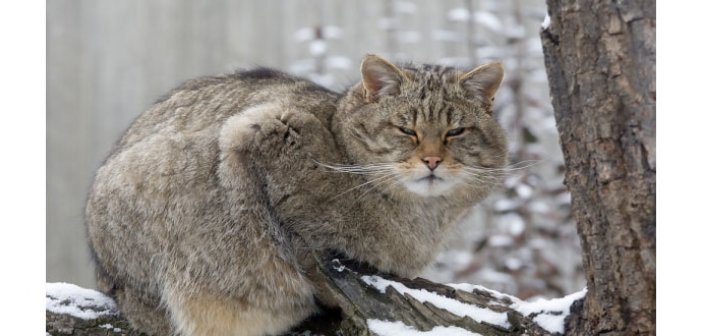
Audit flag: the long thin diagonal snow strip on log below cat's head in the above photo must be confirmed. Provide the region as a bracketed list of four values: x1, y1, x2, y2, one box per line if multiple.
[361, 275, 511, 328]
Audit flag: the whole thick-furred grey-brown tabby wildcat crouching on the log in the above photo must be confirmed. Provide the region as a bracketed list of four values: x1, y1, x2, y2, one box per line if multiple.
[86, 55, 507, 336]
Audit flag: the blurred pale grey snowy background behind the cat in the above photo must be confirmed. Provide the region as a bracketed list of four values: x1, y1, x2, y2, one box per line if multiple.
[46, 0, 585, 299]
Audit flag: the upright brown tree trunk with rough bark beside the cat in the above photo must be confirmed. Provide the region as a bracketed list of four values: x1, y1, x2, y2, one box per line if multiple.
[541, 0, 656, 335]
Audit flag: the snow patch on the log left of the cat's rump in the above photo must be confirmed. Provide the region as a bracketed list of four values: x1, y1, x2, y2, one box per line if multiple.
[46, 282, 117, 320]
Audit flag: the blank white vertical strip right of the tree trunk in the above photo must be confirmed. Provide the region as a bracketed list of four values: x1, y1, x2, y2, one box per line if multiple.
[656, 1, 702, 335]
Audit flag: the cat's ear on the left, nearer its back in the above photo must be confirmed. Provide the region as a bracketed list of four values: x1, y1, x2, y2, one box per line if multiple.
[361, 54, 407, 100]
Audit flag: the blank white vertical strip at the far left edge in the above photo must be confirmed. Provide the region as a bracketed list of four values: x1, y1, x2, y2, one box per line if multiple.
[0, 1, 46, 335]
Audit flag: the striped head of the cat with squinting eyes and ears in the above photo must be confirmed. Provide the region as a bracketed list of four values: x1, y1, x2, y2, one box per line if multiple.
[338, 55, 507, 197]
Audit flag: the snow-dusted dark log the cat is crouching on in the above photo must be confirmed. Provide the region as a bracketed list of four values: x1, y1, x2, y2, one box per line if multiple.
[46, 255, 585, 336]
